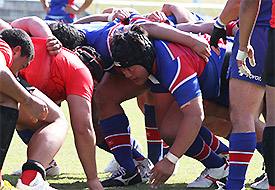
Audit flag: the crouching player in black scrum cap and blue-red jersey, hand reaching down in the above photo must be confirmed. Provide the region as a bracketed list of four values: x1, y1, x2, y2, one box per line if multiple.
[111, 23, 232, 188]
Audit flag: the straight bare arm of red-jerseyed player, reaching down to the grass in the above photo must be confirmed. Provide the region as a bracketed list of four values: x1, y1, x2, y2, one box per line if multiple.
[67, 95, 103, 189]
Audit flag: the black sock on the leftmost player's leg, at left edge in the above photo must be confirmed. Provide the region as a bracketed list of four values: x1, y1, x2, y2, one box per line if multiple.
[0, 106, 18, 169]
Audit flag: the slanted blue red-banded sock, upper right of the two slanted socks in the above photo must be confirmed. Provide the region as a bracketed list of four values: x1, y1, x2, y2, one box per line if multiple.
[199, 126, 229, 154]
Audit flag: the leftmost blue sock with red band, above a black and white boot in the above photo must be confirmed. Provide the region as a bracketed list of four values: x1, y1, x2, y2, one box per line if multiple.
[100, 113, 136, 172]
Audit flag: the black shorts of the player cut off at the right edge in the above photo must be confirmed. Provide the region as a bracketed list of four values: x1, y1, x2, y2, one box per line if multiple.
[263, 28, 275, 87]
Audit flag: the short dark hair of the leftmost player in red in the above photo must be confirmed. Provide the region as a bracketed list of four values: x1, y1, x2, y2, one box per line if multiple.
[0, 28, 34, 60]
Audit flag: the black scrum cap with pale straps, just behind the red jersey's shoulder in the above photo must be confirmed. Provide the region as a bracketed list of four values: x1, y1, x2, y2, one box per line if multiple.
[74, 46, 104, 82]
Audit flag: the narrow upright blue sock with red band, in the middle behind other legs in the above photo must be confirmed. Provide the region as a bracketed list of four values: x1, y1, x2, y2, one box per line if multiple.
[144, 104, 163, 164]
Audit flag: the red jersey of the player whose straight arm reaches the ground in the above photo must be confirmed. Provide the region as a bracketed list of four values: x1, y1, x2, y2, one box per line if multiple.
[19, 38, 94, 103]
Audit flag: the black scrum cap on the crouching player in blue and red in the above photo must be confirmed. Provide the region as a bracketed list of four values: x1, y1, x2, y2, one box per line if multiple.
[111, 23, 156, 74]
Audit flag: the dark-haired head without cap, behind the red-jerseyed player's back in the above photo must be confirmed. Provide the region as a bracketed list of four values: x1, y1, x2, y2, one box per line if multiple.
[49, 22, 87, 51]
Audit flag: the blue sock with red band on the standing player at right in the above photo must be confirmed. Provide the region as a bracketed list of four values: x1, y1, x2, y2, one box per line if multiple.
[226, 132, 257, 189]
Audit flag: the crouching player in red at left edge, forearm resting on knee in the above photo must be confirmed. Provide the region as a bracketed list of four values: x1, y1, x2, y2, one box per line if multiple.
[0, 25, 68, 189]
